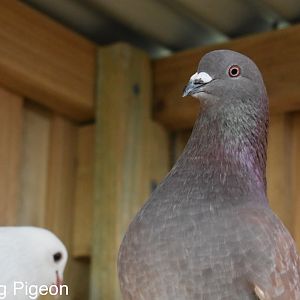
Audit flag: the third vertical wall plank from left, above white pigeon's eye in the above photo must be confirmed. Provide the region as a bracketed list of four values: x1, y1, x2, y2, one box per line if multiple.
[46, 115, 76, 240]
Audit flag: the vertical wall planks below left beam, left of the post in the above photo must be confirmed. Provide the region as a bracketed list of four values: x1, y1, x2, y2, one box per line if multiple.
[0, 91, 92, 299]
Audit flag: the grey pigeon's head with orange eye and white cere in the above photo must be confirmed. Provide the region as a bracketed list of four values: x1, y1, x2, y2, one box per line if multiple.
[183, 50, 267, 112]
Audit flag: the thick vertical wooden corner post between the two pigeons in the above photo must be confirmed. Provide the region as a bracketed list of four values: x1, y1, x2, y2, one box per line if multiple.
[90, 44, 169, 300]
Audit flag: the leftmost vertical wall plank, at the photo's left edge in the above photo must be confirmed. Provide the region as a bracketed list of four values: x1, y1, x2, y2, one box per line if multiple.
[0, 88, 23, 226]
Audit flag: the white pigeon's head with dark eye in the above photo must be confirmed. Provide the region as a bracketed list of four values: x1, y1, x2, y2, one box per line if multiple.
[0, 226, 68, 286]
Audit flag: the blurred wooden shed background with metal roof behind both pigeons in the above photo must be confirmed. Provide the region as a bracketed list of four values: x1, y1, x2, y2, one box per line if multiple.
[0, 0, 300, 300]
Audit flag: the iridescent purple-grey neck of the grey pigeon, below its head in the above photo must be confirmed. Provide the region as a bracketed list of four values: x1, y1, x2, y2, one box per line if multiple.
[175, 108, 268, 204]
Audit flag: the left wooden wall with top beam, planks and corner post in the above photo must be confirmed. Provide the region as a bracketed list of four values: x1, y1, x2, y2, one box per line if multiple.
[0, 0, 169, 300]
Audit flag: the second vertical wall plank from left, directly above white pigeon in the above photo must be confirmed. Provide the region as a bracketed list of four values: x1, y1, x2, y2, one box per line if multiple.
[18, 104, 51, 226]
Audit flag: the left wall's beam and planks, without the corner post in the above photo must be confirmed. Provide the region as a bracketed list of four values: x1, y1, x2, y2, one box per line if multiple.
[0, 0, 96, 300]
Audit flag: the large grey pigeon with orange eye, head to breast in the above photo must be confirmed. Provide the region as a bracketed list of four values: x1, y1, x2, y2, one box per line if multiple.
[118, 50, 300, 300]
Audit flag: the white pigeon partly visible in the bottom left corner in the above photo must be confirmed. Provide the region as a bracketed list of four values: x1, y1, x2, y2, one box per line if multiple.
[0, 226, 68, 300]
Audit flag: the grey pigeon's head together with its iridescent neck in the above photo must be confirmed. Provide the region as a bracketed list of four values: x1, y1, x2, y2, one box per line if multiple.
[183, 50, 269, 193]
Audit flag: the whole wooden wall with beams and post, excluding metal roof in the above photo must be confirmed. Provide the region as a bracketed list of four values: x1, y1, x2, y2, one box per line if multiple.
[0, 0, 300, 300]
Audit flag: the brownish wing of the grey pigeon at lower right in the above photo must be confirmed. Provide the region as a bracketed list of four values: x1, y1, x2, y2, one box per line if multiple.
[246, 210, 300, 300]
